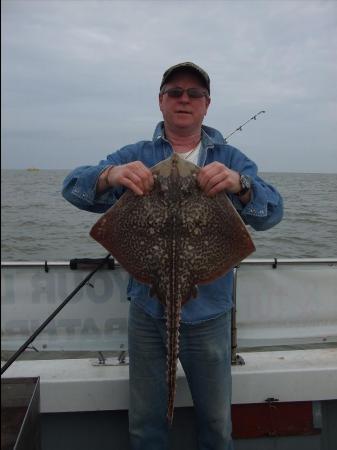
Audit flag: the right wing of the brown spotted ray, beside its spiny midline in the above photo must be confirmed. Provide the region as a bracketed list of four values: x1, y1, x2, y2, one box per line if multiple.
[177, 187, 255, 284]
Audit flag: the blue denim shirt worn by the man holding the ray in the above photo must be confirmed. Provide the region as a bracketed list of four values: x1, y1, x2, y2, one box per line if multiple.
[62, 122, 283, 323]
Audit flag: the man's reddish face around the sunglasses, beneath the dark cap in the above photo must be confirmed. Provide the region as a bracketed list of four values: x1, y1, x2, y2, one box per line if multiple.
[159, 72, 211, 134]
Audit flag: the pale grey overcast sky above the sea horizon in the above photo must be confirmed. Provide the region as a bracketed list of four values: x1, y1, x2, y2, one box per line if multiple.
[1, 0, 337, 173]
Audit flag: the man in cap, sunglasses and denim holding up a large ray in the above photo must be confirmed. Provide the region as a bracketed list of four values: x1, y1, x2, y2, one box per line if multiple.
[63, 62, 283, 450]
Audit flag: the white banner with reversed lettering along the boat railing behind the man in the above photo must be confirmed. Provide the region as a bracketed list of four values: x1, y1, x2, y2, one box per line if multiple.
[1, 258, 337, 351]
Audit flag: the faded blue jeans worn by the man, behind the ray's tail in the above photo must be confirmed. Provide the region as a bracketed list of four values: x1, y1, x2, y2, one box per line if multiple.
[129, 300, 233, 450]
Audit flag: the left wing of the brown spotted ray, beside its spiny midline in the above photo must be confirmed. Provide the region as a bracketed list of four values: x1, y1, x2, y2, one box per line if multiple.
[90, 184, 167, 284]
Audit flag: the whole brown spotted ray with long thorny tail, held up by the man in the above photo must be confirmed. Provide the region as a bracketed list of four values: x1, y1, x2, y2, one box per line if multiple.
[90, 154, 255, 424]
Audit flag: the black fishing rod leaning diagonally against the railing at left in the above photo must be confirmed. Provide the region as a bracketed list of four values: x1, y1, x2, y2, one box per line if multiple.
[1, 253, 111, 375]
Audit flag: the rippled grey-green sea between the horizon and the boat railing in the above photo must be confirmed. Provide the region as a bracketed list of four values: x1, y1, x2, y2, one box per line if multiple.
[1, 170, 337, 261]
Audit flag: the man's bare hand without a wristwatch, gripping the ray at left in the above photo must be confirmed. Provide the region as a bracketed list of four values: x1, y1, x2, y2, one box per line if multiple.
[97, 161, 154, 195]
